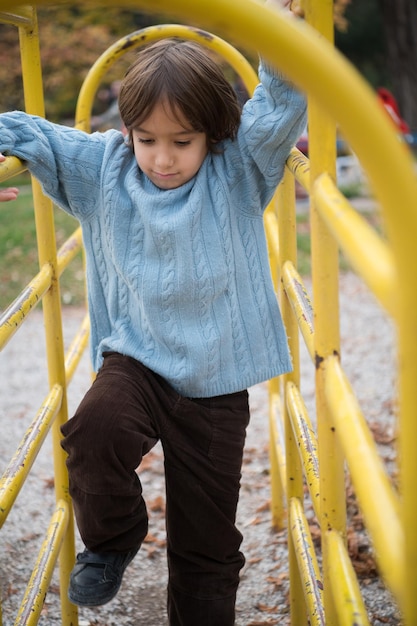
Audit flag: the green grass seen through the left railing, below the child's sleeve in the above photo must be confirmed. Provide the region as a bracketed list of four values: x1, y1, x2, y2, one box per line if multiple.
[0, 175, 85, 310]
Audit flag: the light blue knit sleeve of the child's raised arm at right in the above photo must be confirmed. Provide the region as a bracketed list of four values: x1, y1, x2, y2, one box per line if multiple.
[228, 61, 307, 212]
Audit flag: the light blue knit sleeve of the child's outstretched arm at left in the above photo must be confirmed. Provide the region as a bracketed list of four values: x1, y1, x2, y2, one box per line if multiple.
[0, 111, 114, 218]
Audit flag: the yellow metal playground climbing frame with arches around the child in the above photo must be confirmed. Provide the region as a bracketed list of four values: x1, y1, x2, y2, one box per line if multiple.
[0, 0, 417, 626]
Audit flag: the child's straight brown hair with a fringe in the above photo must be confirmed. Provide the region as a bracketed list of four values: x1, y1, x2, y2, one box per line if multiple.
[119, 38, 240, 149]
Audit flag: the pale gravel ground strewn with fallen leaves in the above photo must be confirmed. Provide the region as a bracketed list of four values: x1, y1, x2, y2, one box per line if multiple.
[0, 273, 400, 626]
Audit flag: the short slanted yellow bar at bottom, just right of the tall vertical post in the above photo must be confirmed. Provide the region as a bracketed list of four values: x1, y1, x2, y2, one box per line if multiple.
[324, 530, 370, 626]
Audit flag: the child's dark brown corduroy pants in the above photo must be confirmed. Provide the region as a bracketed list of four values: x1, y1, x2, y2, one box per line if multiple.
[62, 353, 249, 626]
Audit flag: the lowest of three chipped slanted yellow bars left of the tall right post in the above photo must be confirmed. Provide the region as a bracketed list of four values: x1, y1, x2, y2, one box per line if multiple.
[289, 498, 329, 626]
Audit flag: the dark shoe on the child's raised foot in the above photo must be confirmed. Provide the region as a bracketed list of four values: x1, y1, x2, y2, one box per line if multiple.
[68, 549, 138, 606]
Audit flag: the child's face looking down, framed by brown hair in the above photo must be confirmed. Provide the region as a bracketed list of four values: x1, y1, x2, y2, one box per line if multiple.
[132, 103, 208, 189]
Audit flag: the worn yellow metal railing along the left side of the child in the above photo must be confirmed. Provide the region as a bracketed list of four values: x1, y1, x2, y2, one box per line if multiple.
[0, 7, 84, 626]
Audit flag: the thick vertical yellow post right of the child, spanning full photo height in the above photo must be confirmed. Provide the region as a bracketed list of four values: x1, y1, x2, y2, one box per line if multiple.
[305, 0, 346, 624]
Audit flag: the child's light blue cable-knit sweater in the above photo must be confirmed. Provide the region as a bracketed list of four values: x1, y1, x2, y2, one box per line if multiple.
[0, 66, 305, 397]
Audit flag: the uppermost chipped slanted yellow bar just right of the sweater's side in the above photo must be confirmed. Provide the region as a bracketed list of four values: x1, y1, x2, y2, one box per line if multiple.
[282, 261, 314, 361]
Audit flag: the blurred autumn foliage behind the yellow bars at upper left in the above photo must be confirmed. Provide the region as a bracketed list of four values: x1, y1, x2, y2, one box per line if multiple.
[0, 5, 166, 121]
